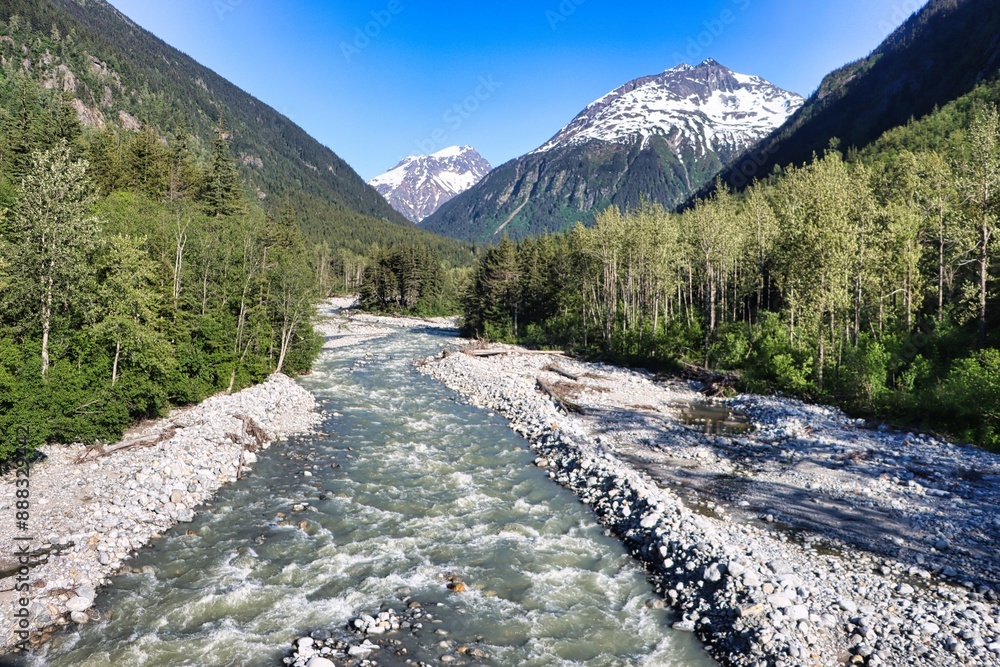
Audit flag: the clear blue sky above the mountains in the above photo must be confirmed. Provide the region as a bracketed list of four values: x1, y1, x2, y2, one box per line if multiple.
[110, 0, 920, 179]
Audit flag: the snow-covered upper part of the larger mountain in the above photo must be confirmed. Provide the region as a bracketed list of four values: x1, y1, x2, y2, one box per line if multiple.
[536, 59, 805, 155]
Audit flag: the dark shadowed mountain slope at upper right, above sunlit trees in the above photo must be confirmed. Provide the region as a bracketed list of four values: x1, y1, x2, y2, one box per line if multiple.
[716, 0, 1000, 194]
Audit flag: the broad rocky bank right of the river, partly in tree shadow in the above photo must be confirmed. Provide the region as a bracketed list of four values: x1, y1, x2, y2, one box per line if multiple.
[421, 348, 1000, 667]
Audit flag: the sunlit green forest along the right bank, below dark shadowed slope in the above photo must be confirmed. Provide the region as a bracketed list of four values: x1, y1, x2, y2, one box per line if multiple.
[464, 85, 1000, 448]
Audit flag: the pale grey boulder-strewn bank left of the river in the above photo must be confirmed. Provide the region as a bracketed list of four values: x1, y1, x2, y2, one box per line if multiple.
[0, 374, 320, 650]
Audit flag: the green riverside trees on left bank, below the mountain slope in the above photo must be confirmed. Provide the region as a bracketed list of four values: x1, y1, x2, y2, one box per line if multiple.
[0, 73, 329, 457]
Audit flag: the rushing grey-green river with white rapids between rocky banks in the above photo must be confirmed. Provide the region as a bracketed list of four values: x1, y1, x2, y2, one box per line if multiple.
[21, 331, 714, 667]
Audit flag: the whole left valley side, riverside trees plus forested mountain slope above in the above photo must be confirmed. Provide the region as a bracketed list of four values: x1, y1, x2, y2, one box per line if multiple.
[0, 0, 473, 462]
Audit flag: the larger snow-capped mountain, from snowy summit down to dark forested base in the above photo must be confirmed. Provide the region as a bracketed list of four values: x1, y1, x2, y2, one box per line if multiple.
[423, 59, 804, 240]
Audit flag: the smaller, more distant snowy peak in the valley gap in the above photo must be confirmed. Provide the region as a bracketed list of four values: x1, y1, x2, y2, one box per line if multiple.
[368, 146, 492, 223]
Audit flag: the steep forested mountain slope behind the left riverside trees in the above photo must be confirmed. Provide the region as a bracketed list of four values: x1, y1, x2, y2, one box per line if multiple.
[0, 0, 470, 262]
